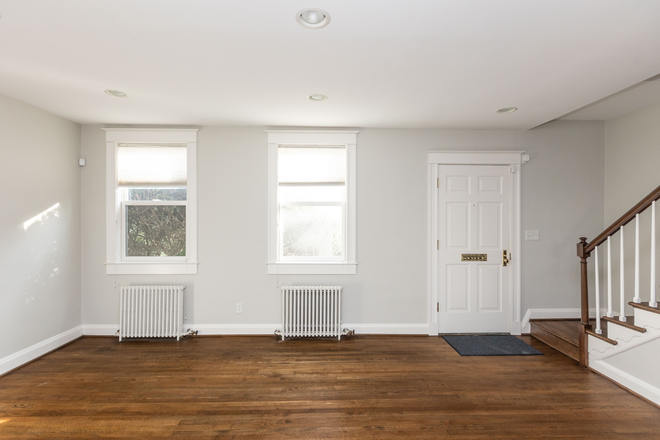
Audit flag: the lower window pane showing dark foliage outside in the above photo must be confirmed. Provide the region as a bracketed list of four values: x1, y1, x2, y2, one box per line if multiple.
[126, 205, 186, 257]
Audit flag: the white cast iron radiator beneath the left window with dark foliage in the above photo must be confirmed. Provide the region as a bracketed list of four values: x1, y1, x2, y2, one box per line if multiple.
[119, 286, 186, 341]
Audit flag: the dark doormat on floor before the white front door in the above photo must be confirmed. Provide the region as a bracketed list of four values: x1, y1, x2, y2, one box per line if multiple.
[443, 335, 543, 356]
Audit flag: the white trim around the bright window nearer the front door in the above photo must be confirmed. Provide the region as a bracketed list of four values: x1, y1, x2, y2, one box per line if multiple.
[266, 130, 358, 275]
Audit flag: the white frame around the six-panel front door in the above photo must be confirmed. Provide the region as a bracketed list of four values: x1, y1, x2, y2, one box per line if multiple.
[426, 150, 529, 336]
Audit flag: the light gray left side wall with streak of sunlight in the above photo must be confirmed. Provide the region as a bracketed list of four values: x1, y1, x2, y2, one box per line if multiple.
[0, 95, 81, 359]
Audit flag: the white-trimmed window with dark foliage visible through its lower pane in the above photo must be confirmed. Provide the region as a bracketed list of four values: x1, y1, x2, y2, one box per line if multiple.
[105, 129, 197, 274]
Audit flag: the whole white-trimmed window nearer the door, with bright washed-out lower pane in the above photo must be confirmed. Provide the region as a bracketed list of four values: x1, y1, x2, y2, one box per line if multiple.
[268, 130, 357, 274]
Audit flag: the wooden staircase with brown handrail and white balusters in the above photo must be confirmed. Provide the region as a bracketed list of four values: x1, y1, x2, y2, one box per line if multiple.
[572, 183, 660, 405]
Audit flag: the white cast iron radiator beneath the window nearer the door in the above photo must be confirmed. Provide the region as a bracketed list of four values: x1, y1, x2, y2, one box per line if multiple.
[275, 286, 352, 340]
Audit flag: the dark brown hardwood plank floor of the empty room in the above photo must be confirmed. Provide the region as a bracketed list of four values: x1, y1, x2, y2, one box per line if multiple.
[0, 336, 660, 439]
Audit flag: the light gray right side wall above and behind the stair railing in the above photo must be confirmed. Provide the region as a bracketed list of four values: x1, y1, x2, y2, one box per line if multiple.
[602, 101, 660, 315]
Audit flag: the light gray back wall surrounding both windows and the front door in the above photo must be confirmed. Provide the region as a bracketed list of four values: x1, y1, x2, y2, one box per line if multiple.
[82, 121, 603, 325]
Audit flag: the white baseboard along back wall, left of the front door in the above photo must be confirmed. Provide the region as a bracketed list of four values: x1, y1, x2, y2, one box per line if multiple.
[83, 324, 429, 336]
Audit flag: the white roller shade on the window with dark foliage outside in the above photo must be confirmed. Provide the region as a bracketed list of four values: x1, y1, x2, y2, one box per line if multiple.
[117, 147, 188, 187]
